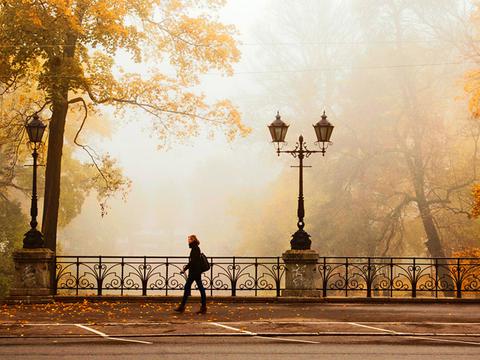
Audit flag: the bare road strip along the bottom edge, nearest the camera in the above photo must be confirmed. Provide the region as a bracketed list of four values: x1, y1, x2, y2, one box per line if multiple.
[0, 337, 479, 360]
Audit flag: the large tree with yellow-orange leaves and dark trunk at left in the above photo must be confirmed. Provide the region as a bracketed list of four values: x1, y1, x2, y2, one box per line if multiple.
[0, 0, 248, 250]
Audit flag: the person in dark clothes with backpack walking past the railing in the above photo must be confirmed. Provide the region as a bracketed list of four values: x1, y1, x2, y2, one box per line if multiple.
[175, 235, 207, 314]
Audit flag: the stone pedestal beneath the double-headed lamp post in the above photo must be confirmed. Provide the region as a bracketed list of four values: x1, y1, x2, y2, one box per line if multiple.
[282, 250, 321, 297]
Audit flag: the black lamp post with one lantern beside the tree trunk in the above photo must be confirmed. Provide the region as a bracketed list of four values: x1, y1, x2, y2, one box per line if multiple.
[23, 114, 47, 249]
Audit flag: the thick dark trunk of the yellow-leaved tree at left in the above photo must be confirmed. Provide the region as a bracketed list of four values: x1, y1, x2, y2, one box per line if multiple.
[42, 97, 68, 252]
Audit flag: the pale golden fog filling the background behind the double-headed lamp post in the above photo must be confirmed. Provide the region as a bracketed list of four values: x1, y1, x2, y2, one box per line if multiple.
[58, 0, 480, 256]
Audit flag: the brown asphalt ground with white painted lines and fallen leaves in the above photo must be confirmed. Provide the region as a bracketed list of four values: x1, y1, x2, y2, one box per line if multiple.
[0, 303, 480, 360]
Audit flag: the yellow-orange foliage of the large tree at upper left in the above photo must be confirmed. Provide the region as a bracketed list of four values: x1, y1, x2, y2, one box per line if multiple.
[0, 0, 249, 139]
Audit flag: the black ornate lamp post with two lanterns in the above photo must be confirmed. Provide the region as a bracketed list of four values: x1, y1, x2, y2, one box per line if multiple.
[268, 111, 333, 250]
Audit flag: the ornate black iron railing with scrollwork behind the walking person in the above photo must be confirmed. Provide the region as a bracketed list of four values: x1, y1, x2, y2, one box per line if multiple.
[55, 256, 480, 298]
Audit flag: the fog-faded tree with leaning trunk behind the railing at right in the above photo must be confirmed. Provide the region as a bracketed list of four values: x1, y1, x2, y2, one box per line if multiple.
[332, 0, 479, 257]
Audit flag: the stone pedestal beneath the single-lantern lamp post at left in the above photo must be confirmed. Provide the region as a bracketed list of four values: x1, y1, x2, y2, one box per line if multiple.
[9, 248, 55, 302]
